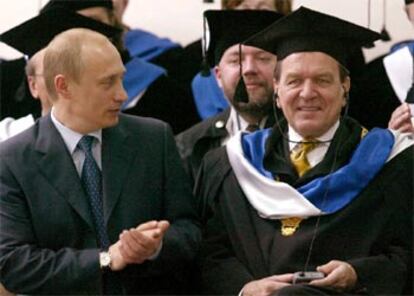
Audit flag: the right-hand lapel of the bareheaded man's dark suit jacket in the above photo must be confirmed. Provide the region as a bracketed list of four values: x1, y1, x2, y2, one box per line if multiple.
[102, 118, 138, 224]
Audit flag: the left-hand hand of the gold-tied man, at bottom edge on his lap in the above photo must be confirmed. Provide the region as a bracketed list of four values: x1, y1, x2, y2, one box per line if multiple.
[242, 273, 293, 296]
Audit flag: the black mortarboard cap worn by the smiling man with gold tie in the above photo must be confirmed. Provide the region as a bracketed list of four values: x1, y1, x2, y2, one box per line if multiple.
[243, 7, 381, 67]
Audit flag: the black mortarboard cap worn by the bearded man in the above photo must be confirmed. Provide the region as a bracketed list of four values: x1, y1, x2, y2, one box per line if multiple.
[204, 10, 283, 67]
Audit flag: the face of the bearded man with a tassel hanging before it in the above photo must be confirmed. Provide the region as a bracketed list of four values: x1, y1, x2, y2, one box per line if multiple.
[215, 44, 276, 115]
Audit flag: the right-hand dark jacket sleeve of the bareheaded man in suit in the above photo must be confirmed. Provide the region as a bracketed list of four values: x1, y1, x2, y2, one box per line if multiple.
[137, 123, 201, 285]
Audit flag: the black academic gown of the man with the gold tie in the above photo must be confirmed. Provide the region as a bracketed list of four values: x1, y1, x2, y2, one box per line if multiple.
[195, 120, 414, 295]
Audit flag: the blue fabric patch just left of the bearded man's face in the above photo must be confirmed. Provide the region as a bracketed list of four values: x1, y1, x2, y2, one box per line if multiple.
[191, 69, 229, 119]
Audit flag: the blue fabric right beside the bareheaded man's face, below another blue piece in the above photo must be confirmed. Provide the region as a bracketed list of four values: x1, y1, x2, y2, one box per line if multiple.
[121, 58, 167, 110]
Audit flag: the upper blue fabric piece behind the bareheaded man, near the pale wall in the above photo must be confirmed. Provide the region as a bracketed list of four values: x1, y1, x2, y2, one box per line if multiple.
[124, 29, 180, 62]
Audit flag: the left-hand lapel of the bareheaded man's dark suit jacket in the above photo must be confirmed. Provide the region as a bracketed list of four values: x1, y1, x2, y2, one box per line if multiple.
[35, 115, 94, 229]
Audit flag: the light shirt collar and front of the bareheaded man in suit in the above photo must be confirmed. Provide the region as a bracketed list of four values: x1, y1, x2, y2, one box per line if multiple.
[51, 107, 102, 176]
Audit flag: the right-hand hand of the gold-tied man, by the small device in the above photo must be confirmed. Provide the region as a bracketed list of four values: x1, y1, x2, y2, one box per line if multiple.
[309, 260, 358, 292]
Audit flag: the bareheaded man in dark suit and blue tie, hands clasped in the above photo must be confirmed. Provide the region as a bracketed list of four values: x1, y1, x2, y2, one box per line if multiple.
[0, 29, 199, 294]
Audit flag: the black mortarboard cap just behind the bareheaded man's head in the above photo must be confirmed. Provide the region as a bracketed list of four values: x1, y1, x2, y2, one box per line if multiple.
[0, 9, 121, 57]
